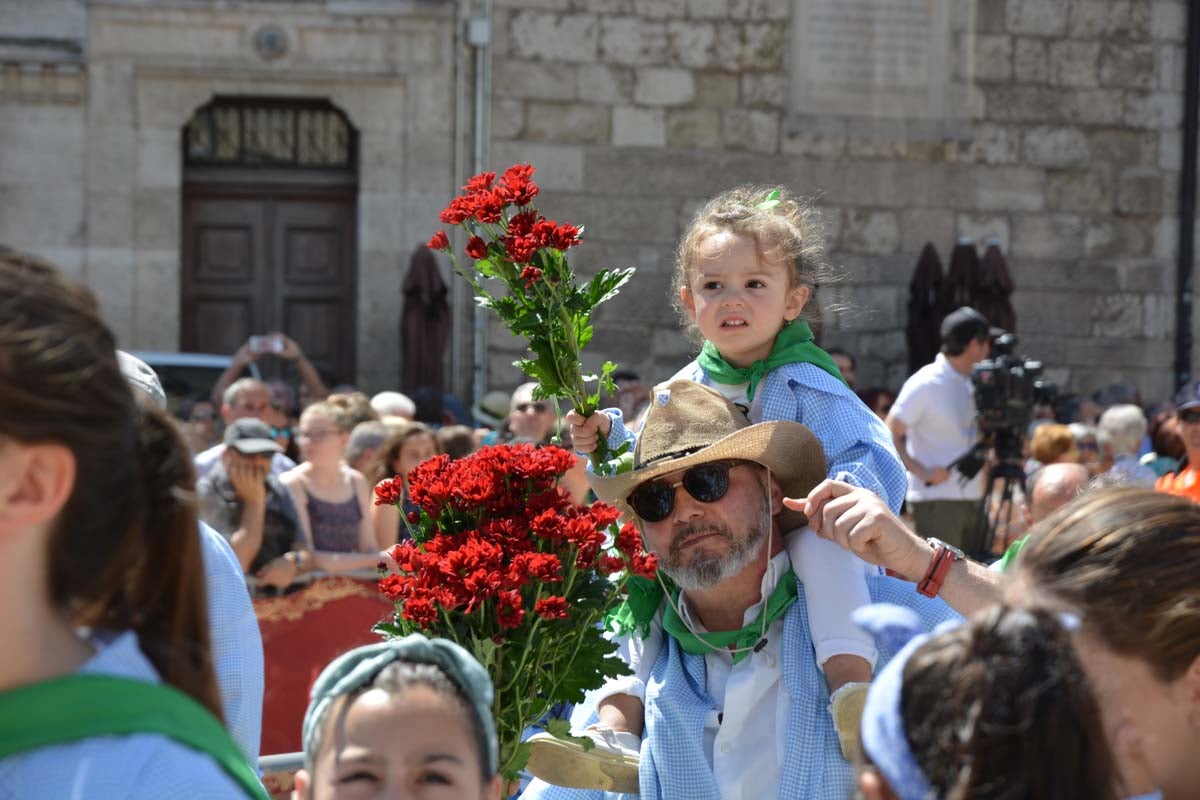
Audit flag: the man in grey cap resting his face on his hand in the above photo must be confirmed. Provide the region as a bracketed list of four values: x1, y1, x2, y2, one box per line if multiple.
[196, 419, 312, 589]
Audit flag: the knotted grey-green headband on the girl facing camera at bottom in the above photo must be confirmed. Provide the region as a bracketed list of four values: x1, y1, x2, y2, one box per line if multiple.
[302, 633, 499, 774]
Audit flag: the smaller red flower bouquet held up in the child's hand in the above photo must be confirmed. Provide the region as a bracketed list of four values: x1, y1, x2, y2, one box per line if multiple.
[428, 164, 634, 475]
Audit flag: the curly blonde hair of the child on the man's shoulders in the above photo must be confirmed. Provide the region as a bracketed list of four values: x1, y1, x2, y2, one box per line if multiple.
[671, 185, 836, 339]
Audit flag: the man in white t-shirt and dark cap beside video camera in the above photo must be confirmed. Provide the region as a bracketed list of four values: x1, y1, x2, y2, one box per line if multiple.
[886, 306, 991, 553]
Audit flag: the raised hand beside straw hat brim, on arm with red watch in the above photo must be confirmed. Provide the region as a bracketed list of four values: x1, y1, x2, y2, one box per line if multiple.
[784, 480, 931, 581]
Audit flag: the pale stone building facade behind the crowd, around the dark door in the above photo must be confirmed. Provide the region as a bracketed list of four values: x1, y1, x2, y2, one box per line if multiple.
[0, 0, 1186, 399]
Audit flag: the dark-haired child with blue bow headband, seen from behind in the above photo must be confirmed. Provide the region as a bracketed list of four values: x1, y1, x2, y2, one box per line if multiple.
[856, 606, 1118, 800]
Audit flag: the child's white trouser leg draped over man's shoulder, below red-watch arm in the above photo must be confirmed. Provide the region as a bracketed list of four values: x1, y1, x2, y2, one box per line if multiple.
[784, 527, 880, 669]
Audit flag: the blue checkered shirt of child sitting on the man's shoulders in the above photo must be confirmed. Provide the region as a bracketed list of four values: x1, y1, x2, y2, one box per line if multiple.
[604, 361, 908, 513]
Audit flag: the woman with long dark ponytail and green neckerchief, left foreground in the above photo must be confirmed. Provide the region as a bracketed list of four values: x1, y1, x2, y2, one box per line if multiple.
[0, 251, 265, 798]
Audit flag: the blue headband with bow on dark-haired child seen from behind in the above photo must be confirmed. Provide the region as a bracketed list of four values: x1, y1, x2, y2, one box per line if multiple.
[852, 603, 962, 800]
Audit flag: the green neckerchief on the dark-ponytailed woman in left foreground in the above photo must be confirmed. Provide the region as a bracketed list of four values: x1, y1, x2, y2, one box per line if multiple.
[0, 674, 269, 800]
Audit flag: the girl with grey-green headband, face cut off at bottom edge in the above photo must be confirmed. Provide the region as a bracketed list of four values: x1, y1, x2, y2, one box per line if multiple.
[295, 633, 502, 800]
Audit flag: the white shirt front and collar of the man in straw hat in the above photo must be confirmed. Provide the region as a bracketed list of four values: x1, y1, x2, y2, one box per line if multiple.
[679, 551, 792, 800]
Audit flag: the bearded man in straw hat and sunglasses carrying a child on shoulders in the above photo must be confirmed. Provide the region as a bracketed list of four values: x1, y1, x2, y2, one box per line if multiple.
[524, 380, 955, 800]
